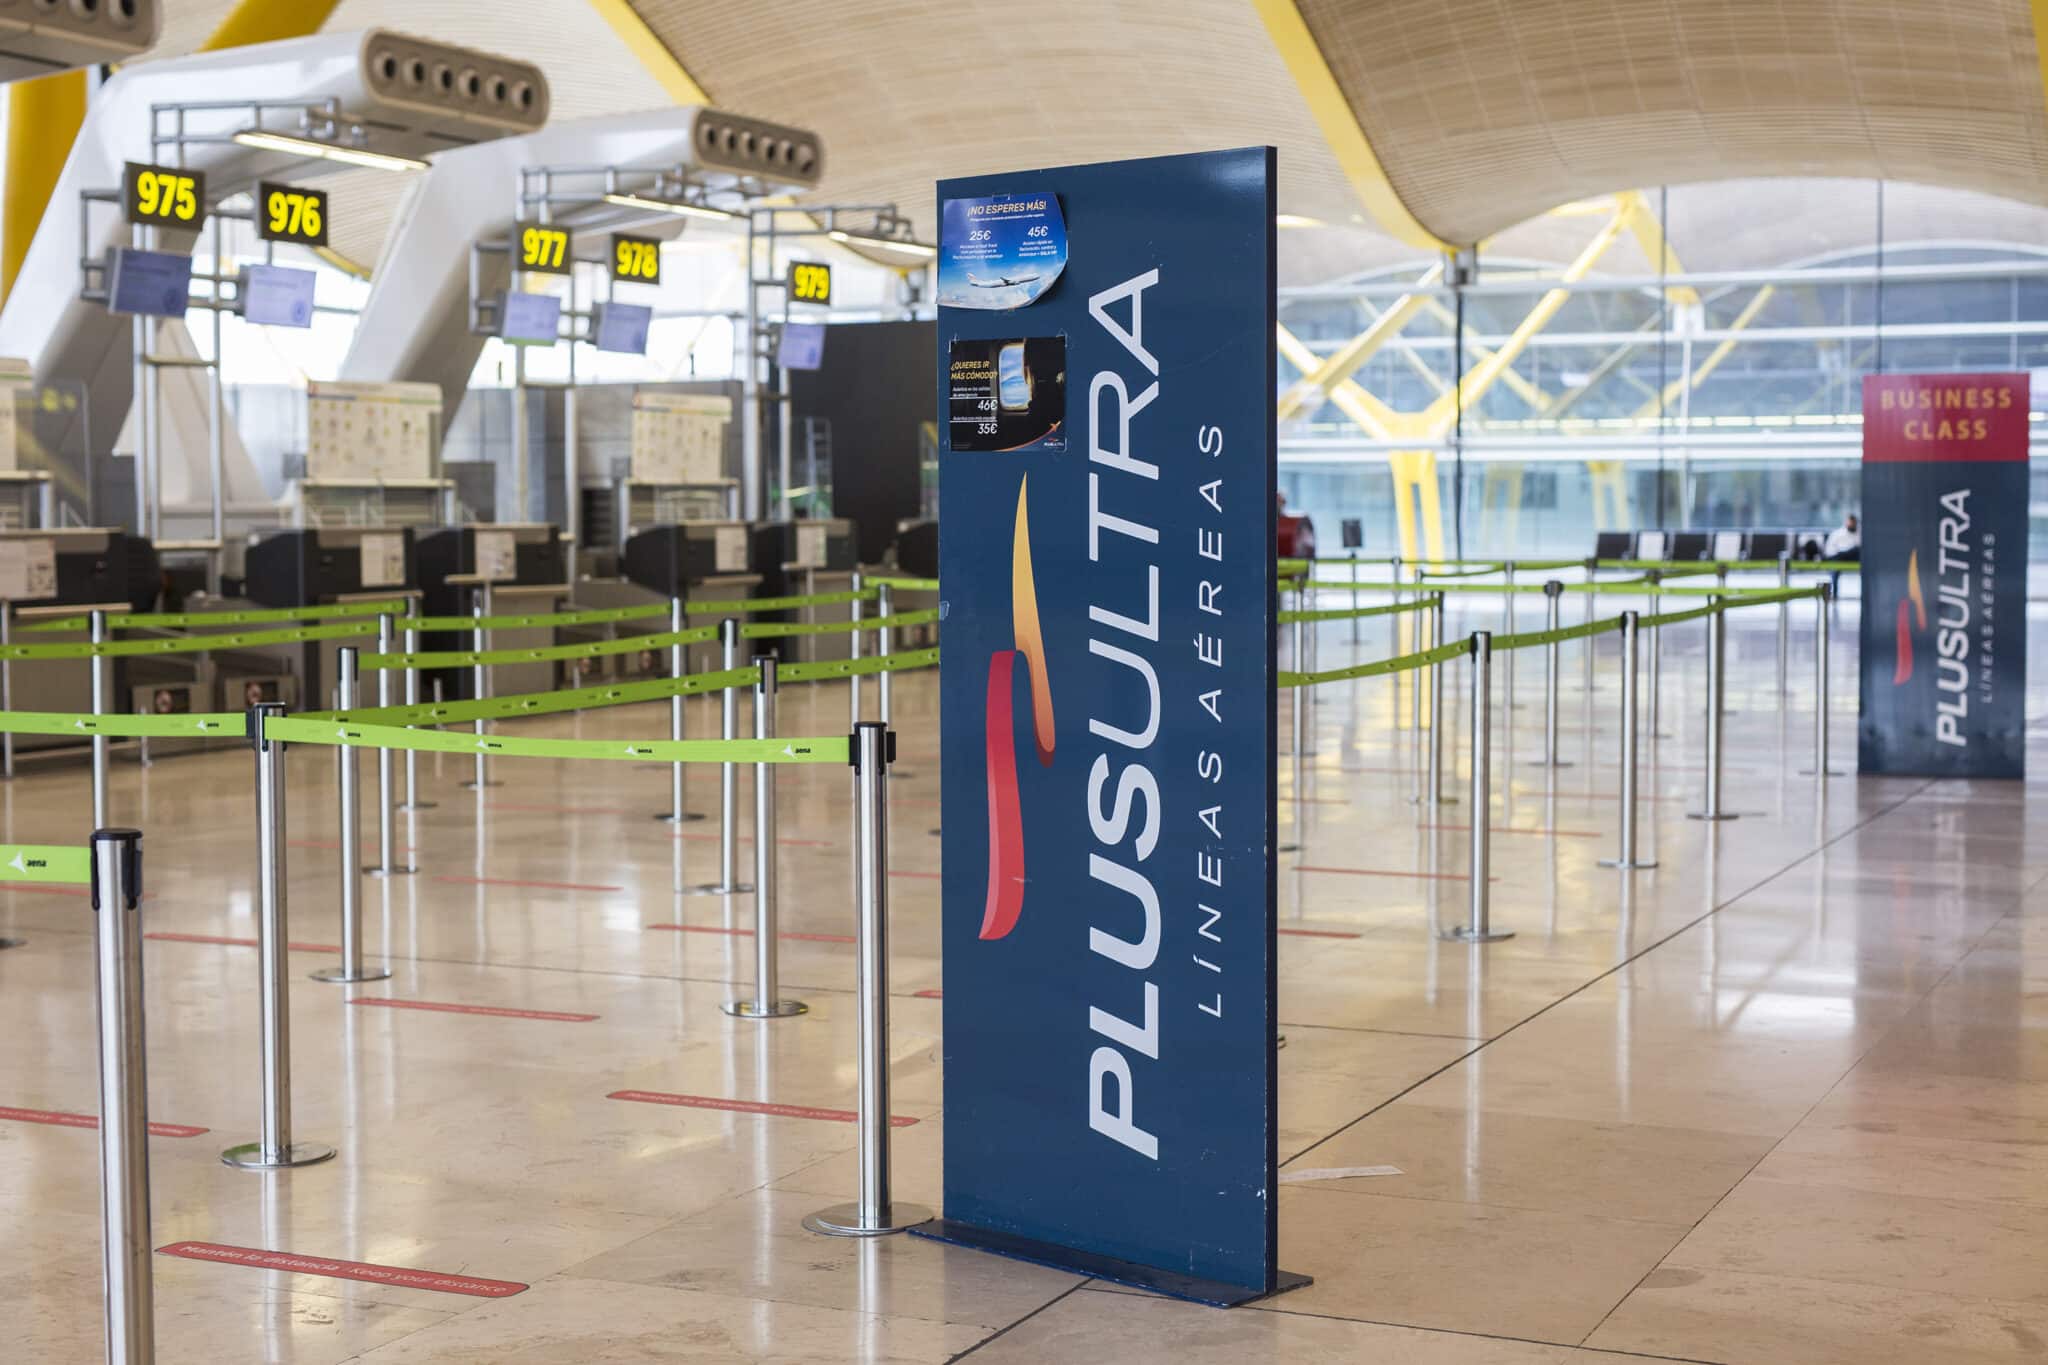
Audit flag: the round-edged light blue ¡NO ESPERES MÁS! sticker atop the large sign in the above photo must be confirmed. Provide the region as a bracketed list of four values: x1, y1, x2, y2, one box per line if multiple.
[938, 186, 1067, 311]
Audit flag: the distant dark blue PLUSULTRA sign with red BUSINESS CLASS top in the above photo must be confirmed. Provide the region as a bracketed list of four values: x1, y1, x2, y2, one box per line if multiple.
[1855, 375, 2030, 778]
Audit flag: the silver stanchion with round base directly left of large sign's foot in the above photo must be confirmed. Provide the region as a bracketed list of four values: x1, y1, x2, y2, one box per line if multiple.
[803, 720, 932, 1236]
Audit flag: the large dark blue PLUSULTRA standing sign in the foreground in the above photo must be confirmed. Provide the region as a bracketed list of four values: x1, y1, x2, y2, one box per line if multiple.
[924, 147, 1300, 1304]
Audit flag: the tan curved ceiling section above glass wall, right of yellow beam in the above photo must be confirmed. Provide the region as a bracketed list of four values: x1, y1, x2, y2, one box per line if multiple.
[1298, 0, 2048, 241]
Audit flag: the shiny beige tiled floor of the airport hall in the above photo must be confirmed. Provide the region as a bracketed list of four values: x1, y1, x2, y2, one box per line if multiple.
[0, 602, 2048, 1365]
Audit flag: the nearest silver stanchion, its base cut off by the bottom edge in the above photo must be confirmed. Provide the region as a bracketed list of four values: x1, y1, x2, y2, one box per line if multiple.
[92, 829, 156, 1365]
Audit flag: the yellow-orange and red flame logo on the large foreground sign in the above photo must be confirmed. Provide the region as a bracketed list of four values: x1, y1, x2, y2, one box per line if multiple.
[981, 479, 1053, 939]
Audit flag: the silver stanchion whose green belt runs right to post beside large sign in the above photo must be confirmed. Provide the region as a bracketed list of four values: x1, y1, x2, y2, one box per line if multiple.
[221, 702, 334, 1171]
